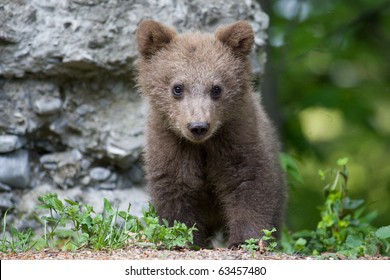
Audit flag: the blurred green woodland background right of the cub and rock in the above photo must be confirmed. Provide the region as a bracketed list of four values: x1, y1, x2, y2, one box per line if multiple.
[259, 0, 390, 230]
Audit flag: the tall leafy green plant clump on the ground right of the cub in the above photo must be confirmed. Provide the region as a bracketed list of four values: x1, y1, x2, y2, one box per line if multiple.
[281, 158, 390, 258]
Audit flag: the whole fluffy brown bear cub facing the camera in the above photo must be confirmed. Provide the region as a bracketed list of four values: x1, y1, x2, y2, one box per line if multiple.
[137, 20, 285, 247]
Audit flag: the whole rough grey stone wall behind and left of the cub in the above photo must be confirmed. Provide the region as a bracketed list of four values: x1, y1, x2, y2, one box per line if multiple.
[0, 0, 268, 221]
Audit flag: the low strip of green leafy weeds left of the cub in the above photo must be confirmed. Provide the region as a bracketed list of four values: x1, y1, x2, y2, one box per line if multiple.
[0, 193, 196, 252]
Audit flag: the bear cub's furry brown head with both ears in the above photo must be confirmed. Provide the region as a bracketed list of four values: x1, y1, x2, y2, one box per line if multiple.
[137, 20, 254, 143]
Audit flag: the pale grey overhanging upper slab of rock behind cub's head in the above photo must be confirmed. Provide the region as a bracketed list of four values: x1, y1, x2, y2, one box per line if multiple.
[0, 0, 268, 77]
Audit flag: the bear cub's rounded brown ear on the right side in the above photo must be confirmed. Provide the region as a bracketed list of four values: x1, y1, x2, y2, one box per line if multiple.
[215, 20, 255, 56]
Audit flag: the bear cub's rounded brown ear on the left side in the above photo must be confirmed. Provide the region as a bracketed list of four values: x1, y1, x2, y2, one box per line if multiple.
[136, 19, 176, 58]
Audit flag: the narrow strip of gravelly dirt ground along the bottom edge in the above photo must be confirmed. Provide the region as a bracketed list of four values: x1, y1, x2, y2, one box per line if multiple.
[0, 247, 390, 260]
